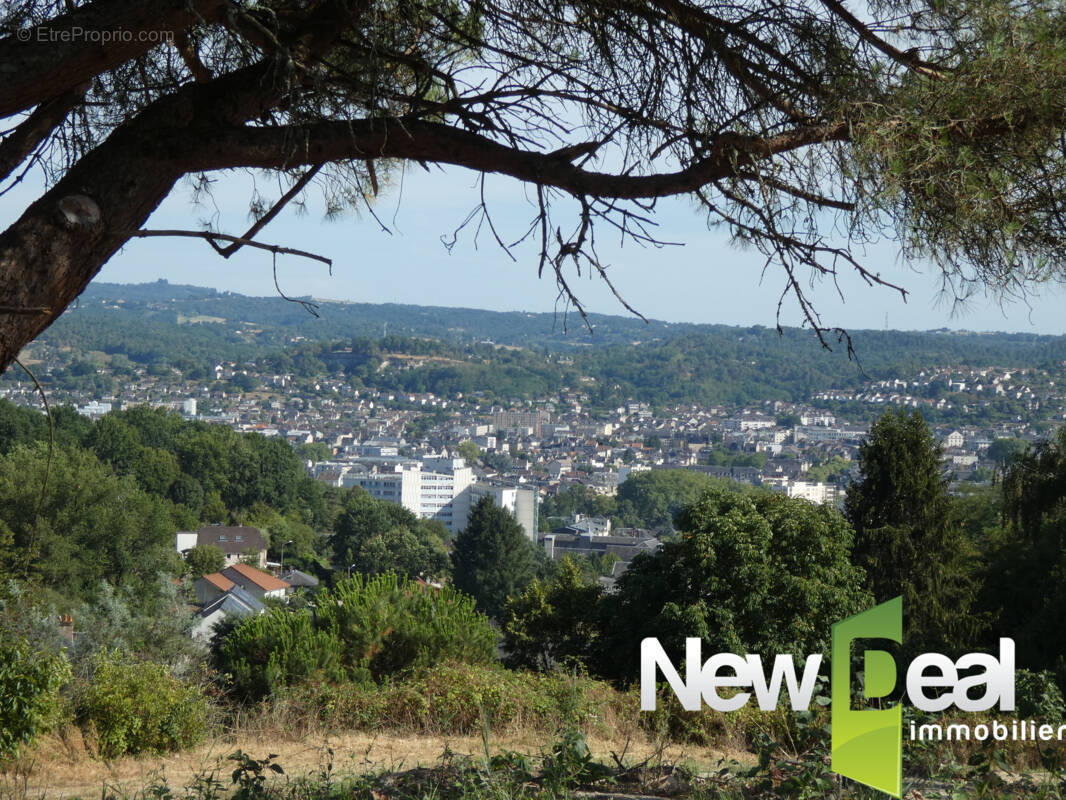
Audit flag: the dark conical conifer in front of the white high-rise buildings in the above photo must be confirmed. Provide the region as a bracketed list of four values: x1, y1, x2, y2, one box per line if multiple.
[452, 497, 537, 618]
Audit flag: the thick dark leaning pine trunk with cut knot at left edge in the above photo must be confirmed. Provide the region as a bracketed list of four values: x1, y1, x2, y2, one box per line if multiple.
[0, 62, 277, 370]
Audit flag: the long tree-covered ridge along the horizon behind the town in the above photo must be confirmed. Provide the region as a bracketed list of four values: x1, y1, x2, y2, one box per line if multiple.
[14, 284, 1066, 414]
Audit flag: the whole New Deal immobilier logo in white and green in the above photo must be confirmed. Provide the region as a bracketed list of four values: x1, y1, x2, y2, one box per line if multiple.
[641, 597, 1014, 798]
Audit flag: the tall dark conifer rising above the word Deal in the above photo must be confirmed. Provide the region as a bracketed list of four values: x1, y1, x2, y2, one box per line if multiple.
[844, 410, 976, 653]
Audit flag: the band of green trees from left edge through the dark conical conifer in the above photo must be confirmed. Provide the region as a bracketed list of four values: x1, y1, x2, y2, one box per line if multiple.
[0, 399, 546, 608]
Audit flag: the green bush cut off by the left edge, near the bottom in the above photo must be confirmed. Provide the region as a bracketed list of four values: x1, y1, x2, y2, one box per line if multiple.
[0, 633, 70, 759]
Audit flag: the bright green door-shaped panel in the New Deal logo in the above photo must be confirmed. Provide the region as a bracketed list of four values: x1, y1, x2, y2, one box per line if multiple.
[831, 597, 903, 798]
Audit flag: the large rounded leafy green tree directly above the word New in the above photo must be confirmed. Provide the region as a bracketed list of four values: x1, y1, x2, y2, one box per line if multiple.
[595, 490, 870, 679]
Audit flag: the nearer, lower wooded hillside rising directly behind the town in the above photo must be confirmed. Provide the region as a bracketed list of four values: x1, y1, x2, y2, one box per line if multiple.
[258, 327, 1066, 409]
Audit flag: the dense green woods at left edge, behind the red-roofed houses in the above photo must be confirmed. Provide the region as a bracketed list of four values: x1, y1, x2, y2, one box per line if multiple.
[0, 400, 339, 605]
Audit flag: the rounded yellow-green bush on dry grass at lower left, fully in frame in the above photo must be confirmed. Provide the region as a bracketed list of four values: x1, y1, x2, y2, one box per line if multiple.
[77, 651, 208, 758]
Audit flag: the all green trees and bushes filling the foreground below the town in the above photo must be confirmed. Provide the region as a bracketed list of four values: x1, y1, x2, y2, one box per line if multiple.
[0, 404, 1066, 797]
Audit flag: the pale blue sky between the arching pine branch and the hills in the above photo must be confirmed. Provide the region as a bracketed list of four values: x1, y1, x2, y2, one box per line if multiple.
[0, 166, 1066, 334]
